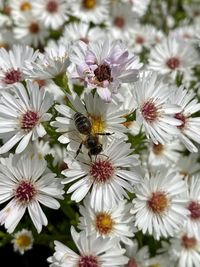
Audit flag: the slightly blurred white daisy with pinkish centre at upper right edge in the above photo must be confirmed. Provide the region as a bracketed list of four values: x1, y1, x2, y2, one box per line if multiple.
[148, 37, 199, 77]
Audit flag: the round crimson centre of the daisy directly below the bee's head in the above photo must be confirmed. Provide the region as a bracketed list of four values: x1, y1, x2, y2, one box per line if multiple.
[90, 160, 114, 183]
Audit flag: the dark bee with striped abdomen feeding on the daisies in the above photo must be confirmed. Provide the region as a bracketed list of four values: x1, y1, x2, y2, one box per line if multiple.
[74, 112, 112, 158]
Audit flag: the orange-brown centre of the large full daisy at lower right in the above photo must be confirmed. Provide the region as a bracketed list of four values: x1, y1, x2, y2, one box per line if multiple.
[147, 192, 168, 214]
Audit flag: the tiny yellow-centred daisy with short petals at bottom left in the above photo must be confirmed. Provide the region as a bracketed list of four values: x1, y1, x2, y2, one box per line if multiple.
[11, 229, 34, 255]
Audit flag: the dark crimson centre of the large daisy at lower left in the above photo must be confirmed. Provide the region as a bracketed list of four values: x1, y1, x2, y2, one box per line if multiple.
[15, 180, 36, 204]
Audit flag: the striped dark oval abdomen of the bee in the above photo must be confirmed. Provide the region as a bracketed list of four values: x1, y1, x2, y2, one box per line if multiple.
[74, 112, 92, 135]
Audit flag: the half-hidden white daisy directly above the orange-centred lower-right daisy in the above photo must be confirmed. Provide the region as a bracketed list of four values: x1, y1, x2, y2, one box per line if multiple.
[148, 140, 183, 166]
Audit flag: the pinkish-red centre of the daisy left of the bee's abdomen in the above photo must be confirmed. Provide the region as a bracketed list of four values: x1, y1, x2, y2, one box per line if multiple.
[21, 110, 39, 133]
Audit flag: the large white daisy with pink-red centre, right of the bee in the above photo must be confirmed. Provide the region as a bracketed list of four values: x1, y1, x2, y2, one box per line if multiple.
[134, 73, 181, 144]
